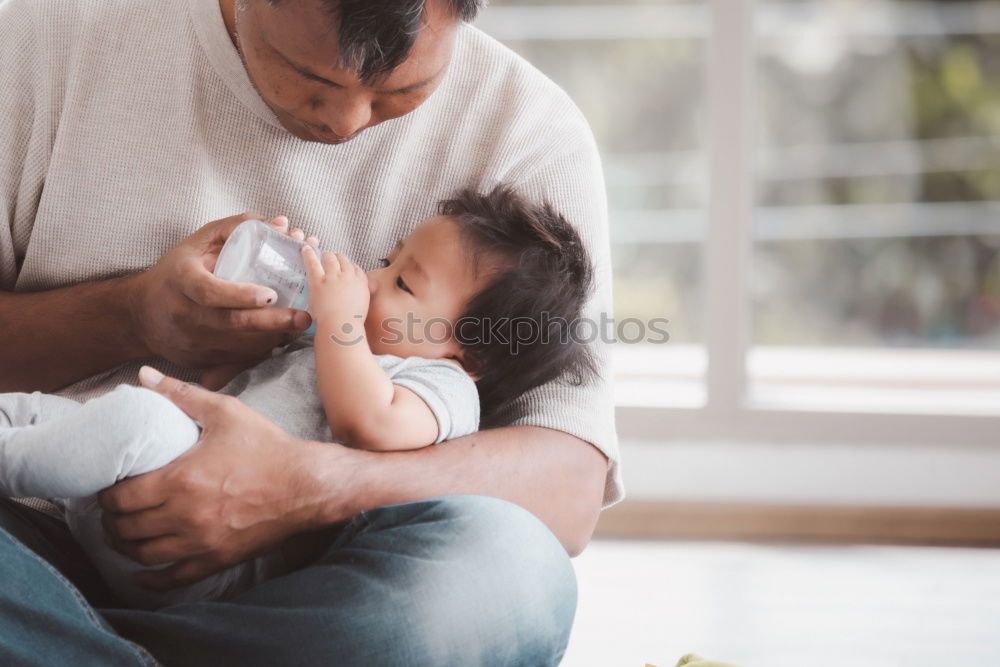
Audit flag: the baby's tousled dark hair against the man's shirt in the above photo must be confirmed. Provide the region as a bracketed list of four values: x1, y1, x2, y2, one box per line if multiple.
[438, 185, 598, 427]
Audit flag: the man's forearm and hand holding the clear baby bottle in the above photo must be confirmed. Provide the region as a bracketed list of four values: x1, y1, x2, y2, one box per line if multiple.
[0, 213, 309, 391]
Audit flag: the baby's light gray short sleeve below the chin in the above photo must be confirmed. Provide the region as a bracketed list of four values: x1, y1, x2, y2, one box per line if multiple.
[378, 355, 479, 444]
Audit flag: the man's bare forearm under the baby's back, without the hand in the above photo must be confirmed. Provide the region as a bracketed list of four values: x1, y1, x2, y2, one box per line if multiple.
[300, 426, 607, 556]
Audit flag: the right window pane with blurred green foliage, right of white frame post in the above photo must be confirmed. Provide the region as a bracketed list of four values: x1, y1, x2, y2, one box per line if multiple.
[748, 0, 1000, 414]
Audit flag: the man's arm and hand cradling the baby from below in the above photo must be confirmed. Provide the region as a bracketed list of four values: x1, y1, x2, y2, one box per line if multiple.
[100, 368, 608, 589]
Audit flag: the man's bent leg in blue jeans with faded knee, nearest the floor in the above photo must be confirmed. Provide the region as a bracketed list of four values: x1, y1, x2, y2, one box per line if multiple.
[0, 496, 576, 665]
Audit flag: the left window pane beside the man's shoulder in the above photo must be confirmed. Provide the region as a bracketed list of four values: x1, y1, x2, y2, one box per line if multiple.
[477, 0, 710, 407]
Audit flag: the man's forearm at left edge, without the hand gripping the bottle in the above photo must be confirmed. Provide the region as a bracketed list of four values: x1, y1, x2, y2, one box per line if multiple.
[0, 276, 147, 392]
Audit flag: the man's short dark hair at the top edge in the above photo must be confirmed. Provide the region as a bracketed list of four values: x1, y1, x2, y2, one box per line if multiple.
[268, 0, 486, 83]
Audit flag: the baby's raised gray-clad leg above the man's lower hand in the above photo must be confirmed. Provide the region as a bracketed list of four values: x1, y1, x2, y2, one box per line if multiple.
[0, 385, 198, 498]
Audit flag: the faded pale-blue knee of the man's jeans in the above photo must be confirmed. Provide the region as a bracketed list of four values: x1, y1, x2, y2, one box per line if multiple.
[350, 496, 576, 665]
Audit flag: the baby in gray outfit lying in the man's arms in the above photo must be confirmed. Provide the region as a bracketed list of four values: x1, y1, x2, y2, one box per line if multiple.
[0, 186, 596, 608]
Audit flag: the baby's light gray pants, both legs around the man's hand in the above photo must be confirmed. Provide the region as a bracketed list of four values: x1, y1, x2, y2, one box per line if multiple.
[0, 384, 282, 608]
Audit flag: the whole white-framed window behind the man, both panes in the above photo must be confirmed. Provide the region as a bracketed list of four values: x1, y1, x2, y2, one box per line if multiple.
[479, 0, 1000, 452]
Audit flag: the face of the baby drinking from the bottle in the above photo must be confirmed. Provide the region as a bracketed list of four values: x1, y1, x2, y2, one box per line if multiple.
[365, 216, 490, 376]
